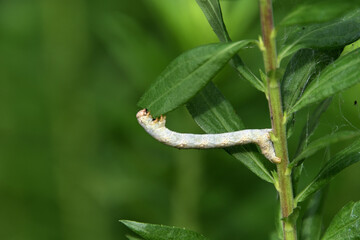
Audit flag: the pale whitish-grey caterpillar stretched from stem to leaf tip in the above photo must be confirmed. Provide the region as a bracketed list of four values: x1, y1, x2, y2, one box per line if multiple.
[136, 109, 281, 163]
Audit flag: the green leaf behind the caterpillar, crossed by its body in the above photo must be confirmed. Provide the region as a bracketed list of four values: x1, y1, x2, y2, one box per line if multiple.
[187, 82, 273, 183]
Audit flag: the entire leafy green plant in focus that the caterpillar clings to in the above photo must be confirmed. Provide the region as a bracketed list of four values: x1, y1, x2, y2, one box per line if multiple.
[134, 0, 360, 240]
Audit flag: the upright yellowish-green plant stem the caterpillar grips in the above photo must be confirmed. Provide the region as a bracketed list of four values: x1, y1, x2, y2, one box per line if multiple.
[259, 0, 297, 240]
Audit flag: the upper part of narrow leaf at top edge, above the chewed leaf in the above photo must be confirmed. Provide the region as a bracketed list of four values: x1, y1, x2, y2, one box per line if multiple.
[196, 0, 231, 42]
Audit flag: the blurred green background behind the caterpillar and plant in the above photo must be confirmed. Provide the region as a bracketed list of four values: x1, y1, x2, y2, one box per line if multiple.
[0, 0, 360, 240]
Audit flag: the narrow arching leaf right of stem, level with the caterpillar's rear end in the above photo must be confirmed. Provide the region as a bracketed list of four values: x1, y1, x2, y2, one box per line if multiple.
[289, 131, 360, 168]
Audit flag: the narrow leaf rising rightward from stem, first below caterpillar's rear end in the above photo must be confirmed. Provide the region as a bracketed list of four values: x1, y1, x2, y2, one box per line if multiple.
[295, 139, 360, 203]
